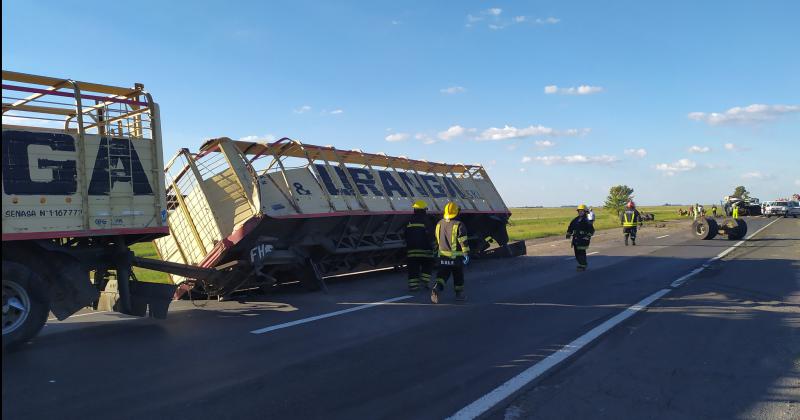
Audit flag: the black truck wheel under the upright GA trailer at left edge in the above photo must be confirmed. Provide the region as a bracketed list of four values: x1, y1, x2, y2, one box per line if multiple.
[3, 260, 50, 349]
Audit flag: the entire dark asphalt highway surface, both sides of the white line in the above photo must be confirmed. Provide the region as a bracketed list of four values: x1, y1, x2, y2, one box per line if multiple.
[3, 218, 800, 419]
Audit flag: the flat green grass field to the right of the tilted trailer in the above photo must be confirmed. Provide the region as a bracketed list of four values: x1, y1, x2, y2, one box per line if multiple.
[508, 206, 700, 240]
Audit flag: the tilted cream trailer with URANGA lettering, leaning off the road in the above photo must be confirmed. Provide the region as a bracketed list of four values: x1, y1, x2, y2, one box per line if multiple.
[155, 138, 525, 297]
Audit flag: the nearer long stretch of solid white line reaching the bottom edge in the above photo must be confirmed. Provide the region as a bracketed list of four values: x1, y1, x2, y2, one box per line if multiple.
[449, 289, 670, 419]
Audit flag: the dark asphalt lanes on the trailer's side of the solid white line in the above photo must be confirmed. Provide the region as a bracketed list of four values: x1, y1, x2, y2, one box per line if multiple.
[3, 219, 792, 418]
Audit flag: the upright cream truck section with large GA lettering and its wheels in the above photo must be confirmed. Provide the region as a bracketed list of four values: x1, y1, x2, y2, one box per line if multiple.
[2, 70, 174, 347]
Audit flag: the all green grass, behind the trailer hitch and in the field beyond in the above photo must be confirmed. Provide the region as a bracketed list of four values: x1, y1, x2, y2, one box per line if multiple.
[131, 206, 700, 283]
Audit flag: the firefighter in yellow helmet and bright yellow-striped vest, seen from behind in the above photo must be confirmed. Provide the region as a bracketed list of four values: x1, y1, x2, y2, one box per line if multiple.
[431, 201, 469, 303]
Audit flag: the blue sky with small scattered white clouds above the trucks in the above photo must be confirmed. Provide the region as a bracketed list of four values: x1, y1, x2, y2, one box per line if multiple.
[2, 0, 800, 205]
